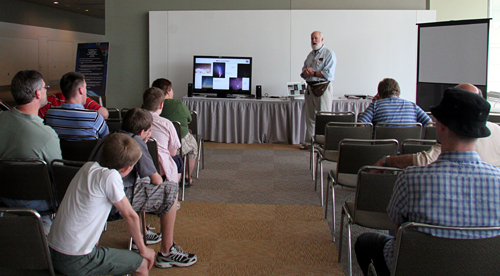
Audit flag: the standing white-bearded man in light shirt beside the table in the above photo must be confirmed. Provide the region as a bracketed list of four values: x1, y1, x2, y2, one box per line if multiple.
[300, 31, 337, 150]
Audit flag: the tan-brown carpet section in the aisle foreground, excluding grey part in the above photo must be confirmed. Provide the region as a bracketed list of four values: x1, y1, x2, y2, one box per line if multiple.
[100, 202, 343, 275]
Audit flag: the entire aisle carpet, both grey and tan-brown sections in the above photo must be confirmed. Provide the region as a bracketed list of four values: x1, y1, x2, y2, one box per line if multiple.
[101, 146, 376, 275]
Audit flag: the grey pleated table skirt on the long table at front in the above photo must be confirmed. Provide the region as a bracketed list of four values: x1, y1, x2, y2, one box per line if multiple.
[182, 97, 371, 144]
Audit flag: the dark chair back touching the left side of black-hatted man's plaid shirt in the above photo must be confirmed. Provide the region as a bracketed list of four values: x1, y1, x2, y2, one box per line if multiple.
[354, 166, 402, 215]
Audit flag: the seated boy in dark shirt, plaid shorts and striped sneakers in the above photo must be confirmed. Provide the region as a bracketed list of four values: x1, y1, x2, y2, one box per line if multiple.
[90, 108, 198, 268]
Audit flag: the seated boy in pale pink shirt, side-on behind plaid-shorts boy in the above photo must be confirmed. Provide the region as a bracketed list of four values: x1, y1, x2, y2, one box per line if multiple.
[142, 87, 182, 183]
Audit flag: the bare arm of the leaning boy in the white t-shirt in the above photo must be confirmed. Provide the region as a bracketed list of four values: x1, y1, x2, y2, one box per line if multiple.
[113, 197, 155, 269]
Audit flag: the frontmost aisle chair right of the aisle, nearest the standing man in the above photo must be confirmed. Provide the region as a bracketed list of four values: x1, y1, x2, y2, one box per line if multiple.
[309, 111, 356, 180]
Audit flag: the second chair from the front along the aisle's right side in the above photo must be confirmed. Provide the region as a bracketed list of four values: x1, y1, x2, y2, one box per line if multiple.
[314, 122, 373, 206]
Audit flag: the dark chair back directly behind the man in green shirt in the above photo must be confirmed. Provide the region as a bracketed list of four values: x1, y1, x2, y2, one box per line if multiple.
[0, 158, 56, 213]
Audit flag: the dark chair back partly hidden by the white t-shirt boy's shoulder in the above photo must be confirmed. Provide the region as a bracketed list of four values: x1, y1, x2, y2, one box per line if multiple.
[51, 159, 85, 204]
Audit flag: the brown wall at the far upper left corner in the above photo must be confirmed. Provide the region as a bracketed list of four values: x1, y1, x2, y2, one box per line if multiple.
[0, 22, 105, 86]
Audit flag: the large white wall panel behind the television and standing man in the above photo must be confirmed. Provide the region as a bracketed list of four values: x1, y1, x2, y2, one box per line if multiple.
[149, 10, 435, 101]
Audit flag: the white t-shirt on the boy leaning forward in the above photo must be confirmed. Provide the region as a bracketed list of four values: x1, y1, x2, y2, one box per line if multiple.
[48, 162, 125, 256]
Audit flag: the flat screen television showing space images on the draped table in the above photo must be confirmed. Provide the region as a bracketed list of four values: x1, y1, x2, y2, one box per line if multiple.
[193, 56, 252, 98]
